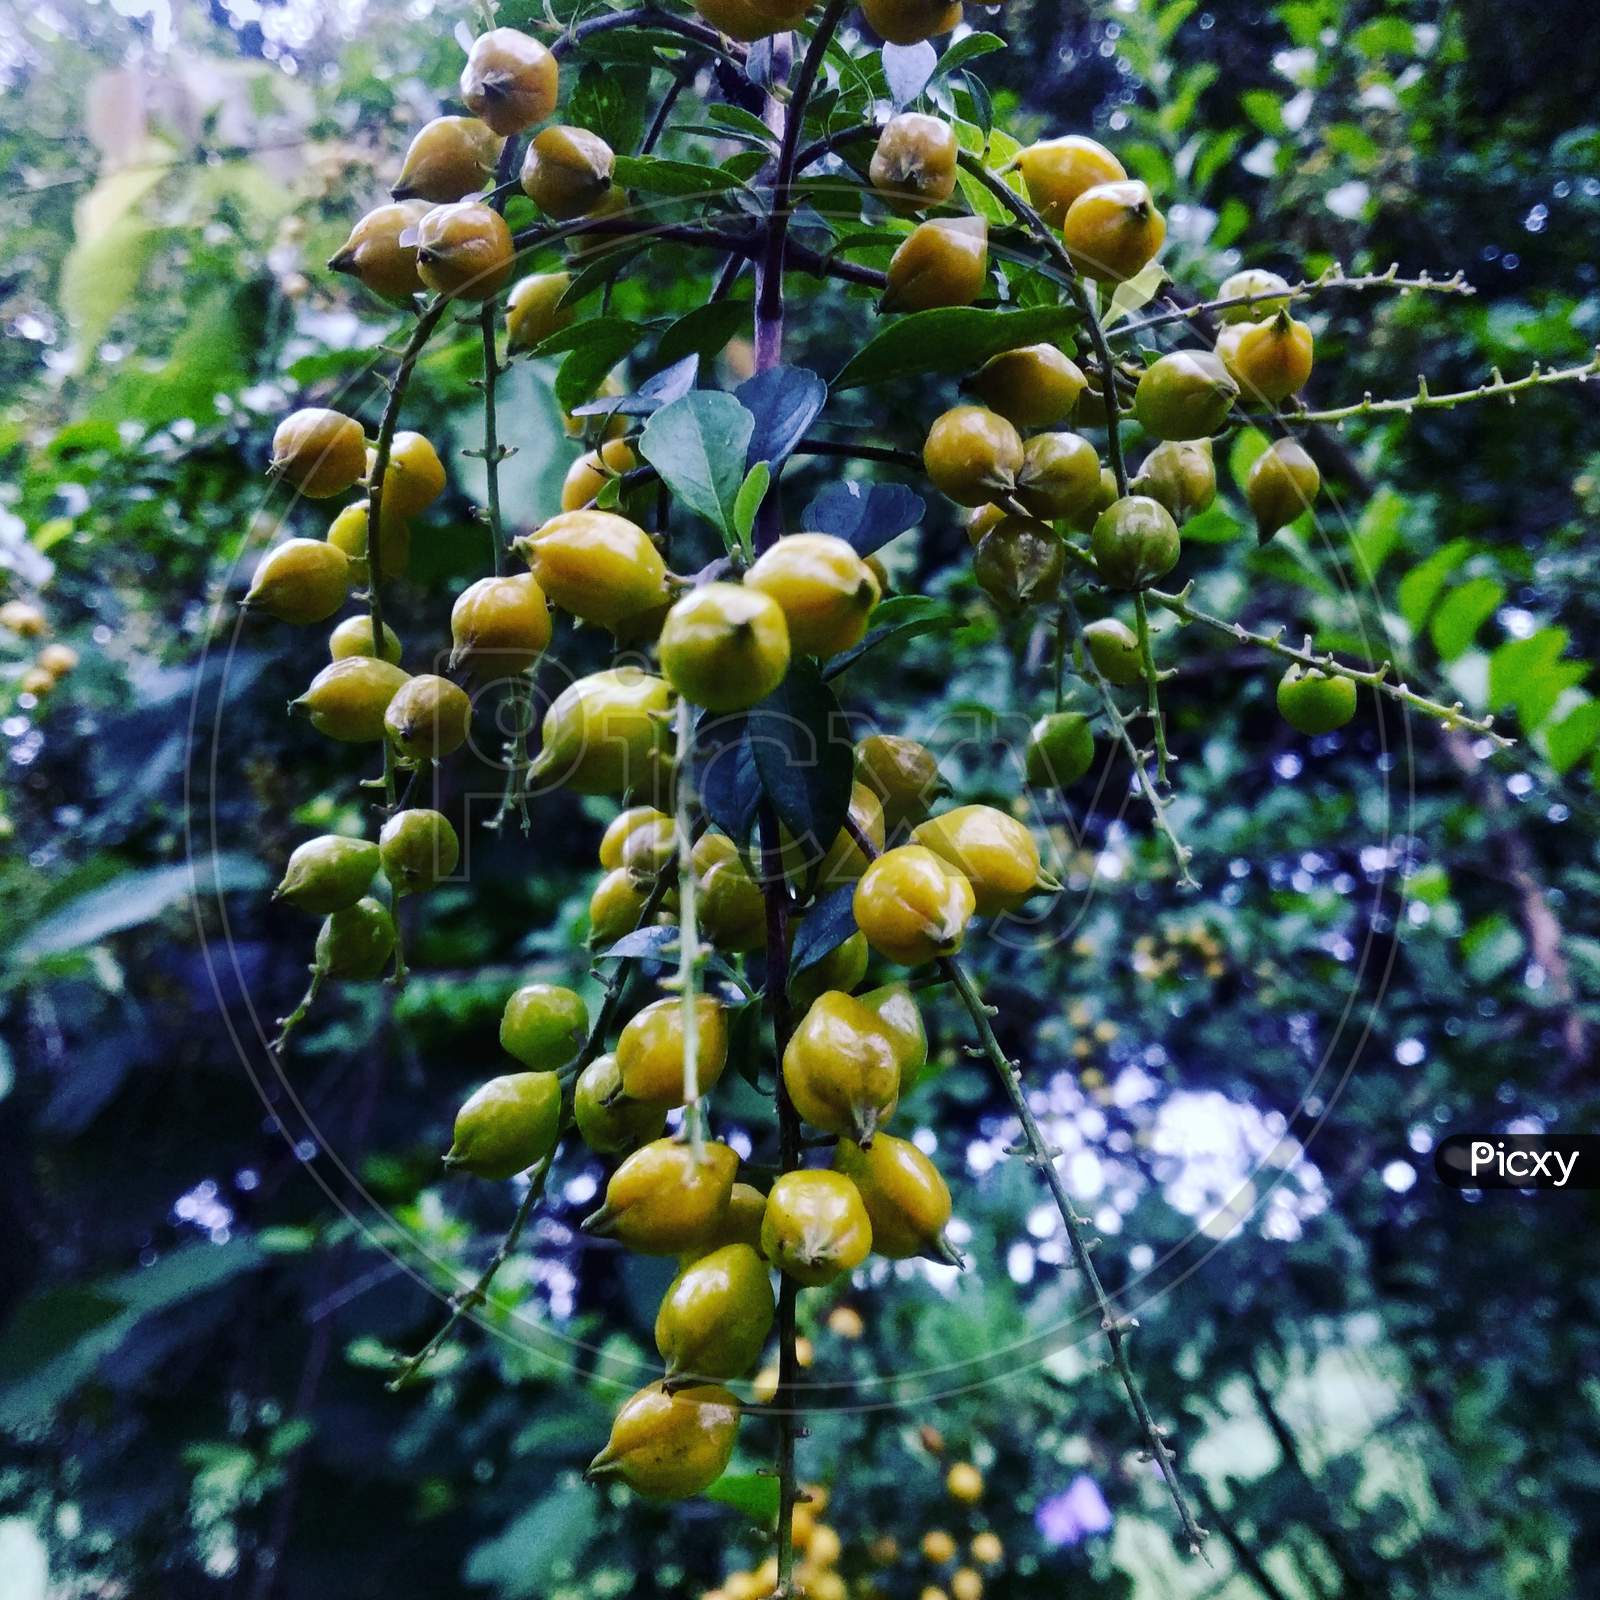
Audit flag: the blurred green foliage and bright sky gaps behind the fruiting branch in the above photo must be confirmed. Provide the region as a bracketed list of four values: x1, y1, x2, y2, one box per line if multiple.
[0, 0, 1600, 1600]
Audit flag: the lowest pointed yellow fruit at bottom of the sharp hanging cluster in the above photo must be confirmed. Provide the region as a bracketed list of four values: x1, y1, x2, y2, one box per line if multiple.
[584, 1382, 741, 1499]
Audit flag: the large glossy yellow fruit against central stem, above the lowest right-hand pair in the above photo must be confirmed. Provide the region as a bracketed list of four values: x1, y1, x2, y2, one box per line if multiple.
[784, 989, 899, 1144]
